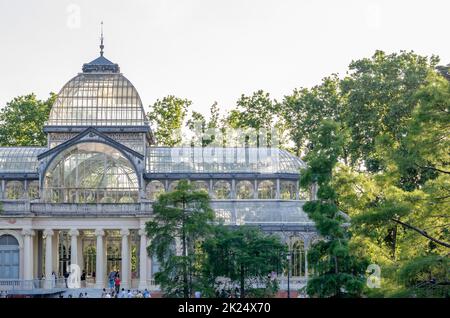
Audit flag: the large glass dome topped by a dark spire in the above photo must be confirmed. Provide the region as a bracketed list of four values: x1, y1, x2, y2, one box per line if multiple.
[47, 71, 146, 126]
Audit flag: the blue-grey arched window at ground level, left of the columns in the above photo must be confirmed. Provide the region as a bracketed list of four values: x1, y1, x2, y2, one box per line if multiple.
[0, 234, 20, 279]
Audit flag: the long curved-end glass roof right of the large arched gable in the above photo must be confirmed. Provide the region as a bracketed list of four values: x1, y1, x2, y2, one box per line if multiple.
[147, 147, 305, 174]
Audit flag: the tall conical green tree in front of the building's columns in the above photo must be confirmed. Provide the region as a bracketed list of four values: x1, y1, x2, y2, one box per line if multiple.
[146, 180, 214, 298]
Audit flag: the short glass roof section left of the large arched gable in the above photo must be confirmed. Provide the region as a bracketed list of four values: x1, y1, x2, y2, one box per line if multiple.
[0, 147, 47, 173]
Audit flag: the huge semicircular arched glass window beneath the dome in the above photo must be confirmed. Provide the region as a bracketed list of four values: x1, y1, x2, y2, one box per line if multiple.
[44, 142, 139, 203]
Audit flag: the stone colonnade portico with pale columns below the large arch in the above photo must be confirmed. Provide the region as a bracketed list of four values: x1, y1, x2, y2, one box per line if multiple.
[3, 221, 153, 289]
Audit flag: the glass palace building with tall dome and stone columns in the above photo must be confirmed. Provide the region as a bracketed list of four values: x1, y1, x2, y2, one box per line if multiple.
[0, 47, 317, 290]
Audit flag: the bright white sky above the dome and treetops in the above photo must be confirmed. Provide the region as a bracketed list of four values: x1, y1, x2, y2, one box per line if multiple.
[0, 0, 450, 117]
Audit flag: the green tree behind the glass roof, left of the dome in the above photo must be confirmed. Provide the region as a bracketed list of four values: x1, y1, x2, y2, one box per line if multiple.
[0, 93, 56, 147]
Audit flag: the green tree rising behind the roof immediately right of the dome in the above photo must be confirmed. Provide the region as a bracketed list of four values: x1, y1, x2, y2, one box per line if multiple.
[147, 95, 192, 147]
